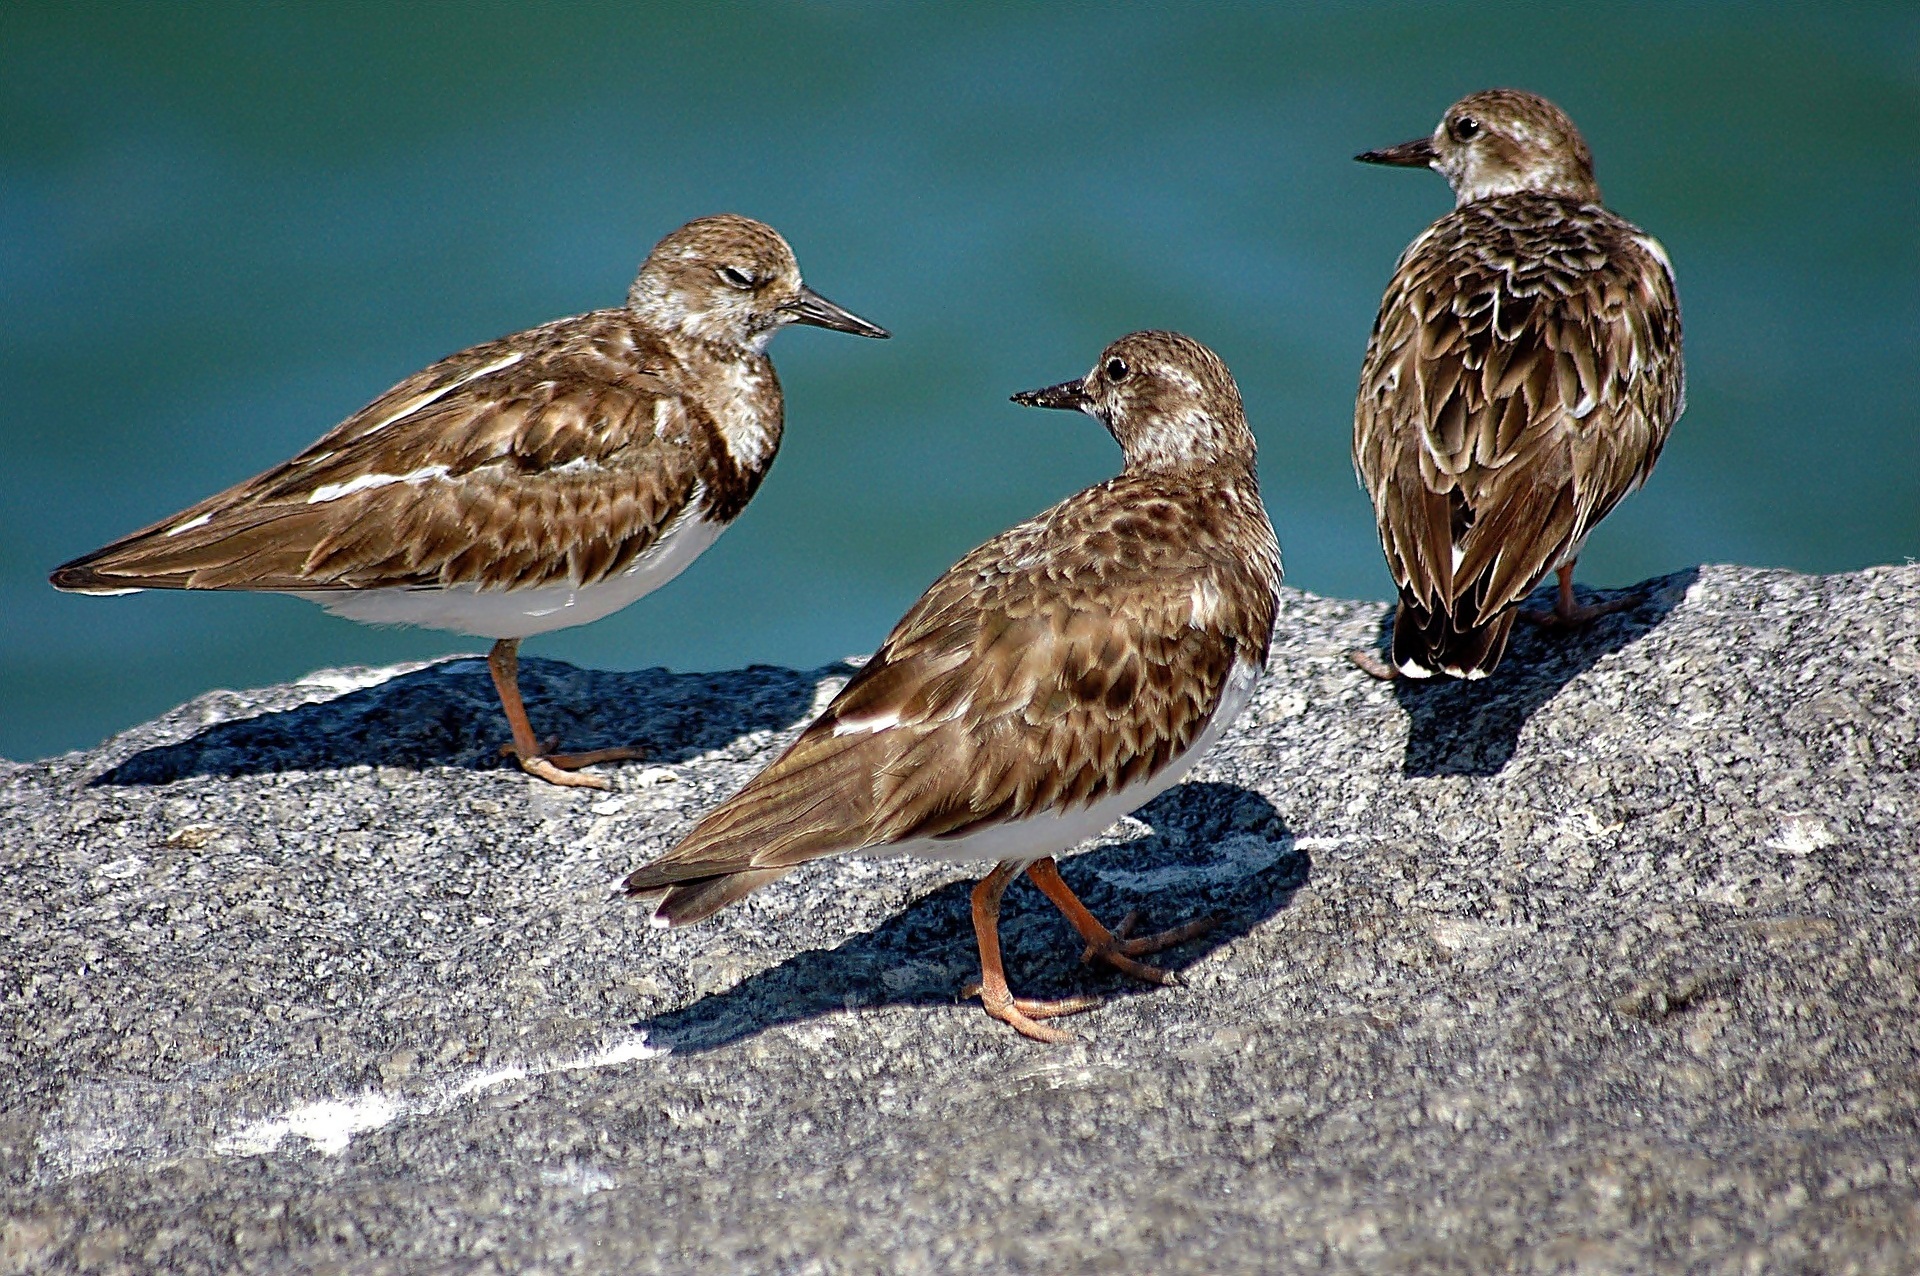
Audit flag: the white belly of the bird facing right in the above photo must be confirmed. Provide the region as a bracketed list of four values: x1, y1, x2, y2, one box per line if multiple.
[290, 514, 726, 639]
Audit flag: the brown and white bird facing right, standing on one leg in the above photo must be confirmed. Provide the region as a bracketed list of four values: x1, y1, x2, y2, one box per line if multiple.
[52, 215, 887, 789]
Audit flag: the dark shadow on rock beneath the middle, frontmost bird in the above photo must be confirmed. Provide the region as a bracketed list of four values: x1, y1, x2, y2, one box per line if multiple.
[634, 783, 1311, 1052]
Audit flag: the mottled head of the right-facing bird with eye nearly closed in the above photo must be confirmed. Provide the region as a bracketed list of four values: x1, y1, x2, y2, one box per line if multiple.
[626, 213, 887, 353]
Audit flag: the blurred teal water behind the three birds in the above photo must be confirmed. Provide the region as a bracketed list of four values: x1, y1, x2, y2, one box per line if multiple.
[0, 0, 1920, 758]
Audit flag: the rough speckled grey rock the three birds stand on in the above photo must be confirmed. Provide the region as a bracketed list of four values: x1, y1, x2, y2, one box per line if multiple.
[0, 566, 1920, 1272]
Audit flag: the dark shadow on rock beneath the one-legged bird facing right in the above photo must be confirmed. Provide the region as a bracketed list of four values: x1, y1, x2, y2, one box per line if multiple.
[88, 658, 852, 787]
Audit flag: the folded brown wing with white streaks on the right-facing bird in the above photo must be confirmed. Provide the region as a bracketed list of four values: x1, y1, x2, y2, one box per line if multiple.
[54, 311, 712, 591]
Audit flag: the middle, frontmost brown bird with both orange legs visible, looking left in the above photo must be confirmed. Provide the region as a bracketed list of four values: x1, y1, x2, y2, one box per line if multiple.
[626, 332, 1281, 1042]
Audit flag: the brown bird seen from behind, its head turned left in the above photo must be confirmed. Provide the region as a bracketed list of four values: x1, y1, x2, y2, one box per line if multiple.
[1354, 88, 1686, 677]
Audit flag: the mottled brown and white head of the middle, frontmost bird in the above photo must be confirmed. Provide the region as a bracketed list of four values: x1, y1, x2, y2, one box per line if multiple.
[1014, 332, 1254, 470]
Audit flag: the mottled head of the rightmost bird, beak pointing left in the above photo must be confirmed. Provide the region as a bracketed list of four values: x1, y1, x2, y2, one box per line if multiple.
[1354, 88, 1599, 207]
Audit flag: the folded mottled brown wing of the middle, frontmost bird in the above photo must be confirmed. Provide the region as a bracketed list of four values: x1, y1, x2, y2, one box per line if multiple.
[626, 478, 1279, 921]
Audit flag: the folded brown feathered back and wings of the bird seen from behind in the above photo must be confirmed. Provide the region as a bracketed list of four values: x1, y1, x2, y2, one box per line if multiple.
[1354, 196, 1684, 624]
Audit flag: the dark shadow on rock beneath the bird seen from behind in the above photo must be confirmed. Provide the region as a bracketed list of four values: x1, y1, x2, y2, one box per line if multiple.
[1380, 568, 1699, 777]
